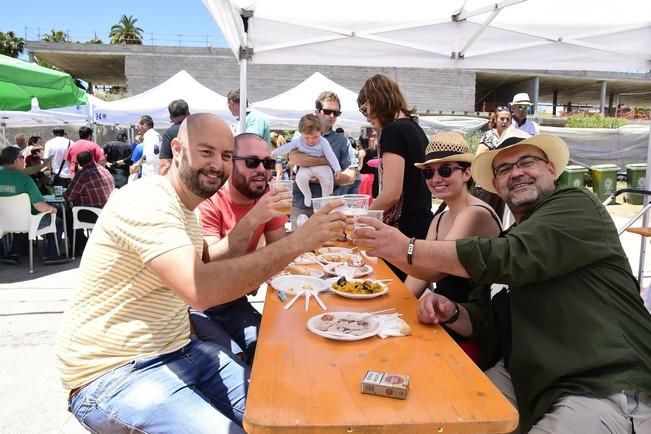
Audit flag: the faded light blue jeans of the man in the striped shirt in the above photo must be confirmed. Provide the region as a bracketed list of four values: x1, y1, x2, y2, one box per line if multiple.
[69, 339, 250, 433]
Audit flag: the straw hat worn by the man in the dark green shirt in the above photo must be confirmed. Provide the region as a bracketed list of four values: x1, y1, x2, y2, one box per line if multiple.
[470, 130, 570, 193]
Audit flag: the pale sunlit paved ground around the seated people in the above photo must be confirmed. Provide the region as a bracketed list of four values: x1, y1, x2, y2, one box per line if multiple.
[0, 201, 651, 434]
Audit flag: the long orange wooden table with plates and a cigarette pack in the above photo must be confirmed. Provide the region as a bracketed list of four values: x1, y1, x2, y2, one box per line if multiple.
[244, 254, 518, 434]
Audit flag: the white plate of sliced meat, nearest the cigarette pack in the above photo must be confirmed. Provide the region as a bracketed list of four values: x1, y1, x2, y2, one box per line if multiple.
[307, 312, 380, 341]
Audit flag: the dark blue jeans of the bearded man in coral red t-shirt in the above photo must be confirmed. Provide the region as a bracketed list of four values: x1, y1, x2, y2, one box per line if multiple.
[190, 297, 262, 364]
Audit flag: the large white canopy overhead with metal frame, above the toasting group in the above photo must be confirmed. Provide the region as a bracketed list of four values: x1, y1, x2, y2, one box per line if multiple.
[202, 0, 651, 181]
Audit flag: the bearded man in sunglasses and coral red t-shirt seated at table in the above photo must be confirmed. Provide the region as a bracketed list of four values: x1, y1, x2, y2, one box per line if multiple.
[190, 133, 291, 363]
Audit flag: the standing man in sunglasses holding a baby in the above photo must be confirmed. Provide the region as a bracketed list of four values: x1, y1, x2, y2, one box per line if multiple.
[289, 91, 357, 228]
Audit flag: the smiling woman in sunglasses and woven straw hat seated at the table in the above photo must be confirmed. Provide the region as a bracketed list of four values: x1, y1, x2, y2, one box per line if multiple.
[405, 132, 502, 360]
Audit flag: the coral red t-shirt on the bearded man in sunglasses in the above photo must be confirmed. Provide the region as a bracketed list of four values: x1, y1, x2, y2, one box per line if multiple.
[199, 185, 287, 253]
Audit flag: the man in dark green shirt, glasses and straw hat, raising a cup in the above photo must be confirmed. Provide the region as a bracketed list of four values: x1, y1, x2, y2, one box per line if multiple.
[353, 134, 651, 433]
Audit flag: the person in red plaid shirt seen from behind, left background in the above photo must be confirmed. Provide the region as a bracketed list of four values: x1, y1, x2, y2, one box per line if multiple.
[63, 151, 115, 251]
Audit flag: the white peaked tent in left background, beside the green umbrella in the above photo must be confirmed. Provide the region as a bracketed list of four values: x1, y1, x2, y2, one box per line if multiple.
[93, 70, 235, 128]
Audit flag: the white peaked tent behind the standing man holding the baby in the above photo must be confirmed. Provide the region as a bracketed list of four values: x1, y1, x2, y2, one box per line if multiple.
[251, 72, 367, 131]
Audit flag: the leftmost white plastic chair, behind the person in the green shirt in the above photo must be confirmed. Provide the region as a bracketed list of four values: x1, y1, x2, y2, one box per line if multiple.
[0, 193, 60, 273]
